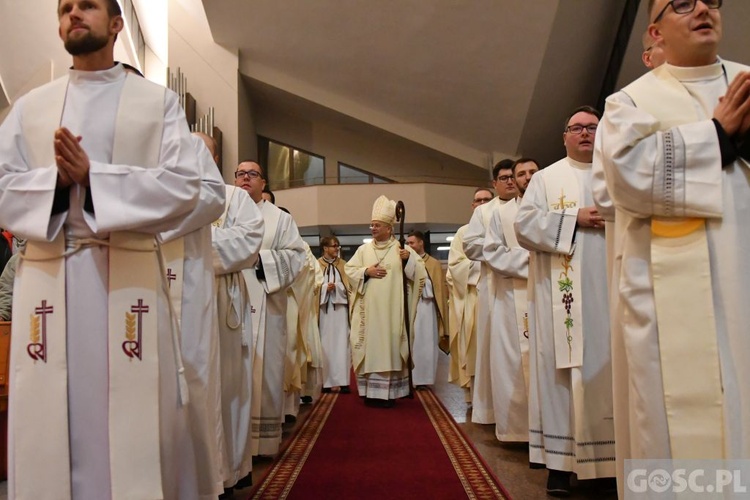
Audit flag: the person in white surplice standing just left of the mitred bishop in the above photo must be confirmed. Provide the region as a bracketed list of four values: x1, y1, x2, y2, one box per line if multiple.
[318, 236, 352, 394]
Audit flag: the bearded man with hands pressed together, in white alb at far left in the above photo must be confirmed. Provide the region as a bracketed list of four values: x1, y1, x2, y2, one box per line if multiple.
[0, 0, 212, 499]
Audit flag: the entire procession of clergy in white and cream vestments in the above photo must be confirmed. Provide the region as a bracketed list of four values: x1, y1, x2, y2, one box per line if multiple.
[0, 0, 750, 499]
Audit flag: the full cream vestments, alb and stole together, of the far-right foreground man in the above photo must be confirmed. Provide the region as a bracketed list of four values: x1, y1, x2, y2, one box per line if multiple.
[595, 61, 750, 480]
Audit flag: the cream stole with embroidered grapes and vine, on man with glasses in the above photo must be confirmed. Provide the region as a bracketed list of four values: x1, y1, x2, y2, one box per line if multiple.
[543, 162, 583, 369]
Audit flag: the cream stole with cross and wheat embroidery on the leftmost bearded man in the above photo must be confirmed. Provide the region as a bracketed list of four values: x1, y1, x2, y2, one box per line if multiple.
[11, 72, 170, 499]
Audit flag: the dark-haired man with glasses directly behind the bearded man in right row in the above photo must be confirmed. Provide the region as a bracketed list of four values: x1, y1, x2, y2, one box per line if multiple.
[463, 158, 516, 424]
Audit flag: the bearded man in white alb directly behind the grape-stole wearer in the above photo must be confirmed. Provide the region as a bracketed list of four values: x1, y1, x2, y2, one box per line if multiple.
[484, 158, 539, 442]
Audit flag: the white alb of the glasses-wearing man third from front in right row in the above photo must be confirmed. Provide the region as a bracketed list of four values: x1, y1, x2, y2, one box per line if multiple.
[463, 197, 505, 424]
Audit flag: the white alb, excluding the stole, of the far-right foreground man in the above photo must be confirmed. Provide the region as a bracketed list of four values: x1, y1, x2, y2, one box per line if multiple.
[595, 61, 750, 479]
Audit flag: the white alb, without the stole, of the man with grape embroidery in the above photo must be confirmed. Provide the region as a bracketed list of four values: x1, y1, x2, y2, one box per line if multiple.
[515, 158, 615, 479]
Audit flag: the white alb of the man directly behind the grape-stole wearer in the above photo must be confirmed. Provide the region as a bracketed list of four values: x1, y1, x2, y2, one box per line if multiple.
[484, 199, 529, 441]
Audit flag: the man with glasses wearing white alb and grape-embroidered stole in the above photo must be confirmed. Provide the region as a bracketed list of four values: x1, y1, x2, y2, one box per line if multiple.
[515, 106, 615, 496]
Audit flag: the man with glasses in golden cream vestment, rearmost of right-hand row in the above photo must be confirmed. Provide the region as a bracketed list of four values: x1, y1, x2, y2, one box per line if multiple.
[445, 188, 494, 406]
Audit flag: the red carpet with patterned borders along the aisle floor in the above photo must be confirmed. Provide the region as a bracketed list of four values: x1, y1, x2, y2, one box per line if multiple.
[251, 391, 510, 499]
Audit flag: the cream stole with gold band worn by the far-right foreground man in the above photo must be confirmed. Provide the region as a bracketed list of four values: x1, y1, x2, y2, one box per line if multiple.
[624, 62, 742, 459]
